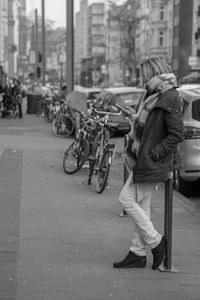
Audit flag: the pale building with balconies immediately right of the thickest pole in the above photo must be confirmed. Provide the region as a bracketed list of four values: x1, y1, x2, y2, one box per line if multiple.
[74, 0, 105, 86]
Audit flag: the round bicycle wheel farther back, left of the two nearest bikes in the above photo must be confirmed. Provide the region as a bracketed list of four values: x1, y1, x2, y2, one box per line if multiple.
[51, 115, 74, 138]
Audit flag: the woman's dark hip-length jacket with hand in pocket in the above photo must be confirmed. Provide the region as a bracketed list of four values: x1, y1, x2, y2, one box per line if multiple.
[133, 89, 184, 183]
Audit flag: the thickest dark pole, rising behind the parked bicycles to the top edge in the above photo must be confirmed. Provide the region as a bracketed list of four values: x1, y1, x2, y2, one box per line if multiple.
[66, 0, 74, 93]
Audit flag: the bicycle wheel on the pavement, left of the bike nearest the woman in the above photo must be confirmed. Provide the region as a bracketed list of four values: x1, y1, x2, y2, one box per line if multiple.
[63, 139, 89, 174]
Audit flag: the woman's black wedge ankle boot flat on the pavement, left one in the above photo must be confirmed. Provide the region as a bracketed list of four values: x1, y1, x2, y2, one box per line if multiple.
[113, 251, 146, 269]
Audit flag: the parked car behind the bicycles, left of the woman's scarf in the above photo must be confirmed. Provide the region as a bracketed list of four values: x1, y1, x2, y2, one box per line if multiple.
[96, 87, 145, 135]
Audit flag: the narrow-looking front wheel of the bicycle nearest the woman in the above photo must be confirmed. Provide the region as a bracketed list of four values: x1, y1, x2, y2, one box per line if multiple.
[96, 150, 112, 193]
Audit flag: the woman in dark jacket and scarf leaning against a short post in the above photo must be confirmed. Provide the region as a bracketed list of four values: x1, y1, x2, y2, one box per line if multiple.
[113, 57, 184, 270]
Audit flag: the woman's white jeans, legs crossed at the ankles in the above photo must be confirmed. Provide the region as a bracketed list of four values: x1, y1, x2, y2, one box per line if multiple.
[119, 172, 162, 256]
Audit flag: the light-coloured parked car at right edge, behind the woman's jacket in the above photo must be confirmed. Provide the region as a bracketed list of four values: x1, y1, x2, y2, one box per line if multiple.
[174, 88, 200, 196]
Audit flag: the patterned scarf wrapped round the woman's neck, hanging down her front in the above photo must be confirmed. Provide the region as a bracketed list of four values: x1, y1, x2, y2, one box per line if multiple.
[132, 73, 177, 157]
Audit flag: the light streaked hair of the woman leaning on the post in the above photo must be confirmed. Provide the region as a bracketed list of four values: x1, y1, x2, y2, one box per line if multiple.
[141, 56, 172, 82]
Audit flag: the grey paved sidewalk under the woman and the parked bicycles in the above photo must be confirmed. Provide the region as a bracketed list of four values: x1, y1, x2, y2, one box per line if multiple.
[0, 115, 200, 300]
